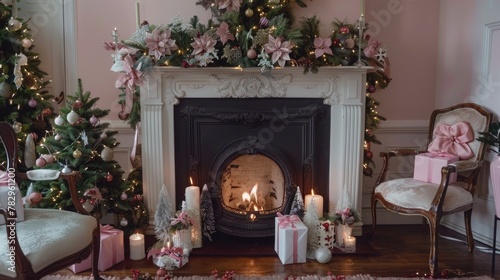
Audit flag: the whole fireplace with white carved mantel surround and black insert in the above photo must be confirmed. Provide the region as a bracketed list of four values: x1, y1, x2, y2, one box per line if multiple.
[141, 67, 368, 236]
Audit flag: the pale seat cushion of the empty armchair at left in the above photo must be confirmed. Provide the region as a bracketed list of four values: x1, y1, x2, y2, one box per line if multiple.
[0, 208, 98, 278]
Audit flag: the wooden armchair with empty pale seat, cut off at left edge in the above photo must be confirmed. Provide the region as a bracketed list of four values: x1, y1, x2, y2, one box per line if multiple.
[0, 123, 101, 280]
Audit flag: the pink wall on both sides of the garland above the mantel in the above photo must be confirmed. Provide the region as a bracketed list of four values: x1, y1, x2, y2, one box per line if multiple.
[76, 0, 439, 120]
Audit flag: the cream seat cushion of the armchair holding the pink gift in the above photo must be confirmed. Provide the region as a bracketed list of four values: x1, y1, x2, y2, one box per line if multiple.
[375, 178, 473, 212]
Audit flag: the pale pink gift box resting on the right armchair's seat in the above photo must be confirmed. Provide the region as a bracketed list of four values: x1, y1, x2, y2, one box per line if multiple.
[413, 153, 458, 184]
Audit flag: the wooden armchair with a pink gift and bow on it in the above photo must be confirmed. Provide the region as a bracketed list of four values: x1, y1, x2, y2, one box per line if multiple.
[368, 103, 491, 276]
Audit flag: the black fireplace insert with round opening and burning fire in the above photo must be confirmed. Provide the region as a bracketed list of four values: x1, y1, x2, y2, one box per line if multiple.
[174, 98, 331, 237]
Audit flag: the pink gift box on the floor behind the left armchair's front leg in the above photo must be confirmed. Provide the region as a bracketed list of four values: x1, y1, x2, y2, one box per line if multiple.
[68, 225, 125, 273]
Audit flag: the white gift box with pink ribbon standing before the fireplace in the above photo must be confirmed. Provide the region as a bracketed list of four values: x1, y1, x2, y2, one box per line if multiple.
[274, 213, 307, 264]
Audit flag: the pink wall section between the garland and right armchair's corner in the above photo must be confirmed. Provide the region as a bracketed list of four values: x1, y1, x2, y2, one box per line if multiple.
[366, 0, 439, 120]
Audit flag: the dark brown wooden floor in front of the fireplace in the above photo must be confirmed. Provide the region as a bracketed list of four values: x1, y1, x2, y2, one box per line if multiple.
[59, 225, 500, 279]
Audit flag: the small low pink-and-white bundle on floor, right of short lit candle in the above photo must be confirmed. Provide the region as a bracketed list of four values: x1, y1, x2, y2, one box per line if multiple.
[147, 247, 189, 270]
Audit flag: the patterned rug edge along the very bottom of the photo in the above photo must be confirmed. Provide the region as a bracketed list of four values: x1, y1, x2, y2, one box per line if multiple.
[42, 274, 494, 280]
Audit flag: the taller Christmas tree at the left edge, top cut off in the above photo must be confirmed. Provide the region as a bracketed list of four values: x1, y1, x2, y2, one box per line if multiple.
[0, 0, 54, 170]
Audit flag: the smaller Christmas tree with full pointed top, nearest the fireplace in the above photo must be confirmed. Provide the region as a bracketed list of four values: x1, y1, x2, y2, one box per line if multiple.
[35, 80, 148, 235]
